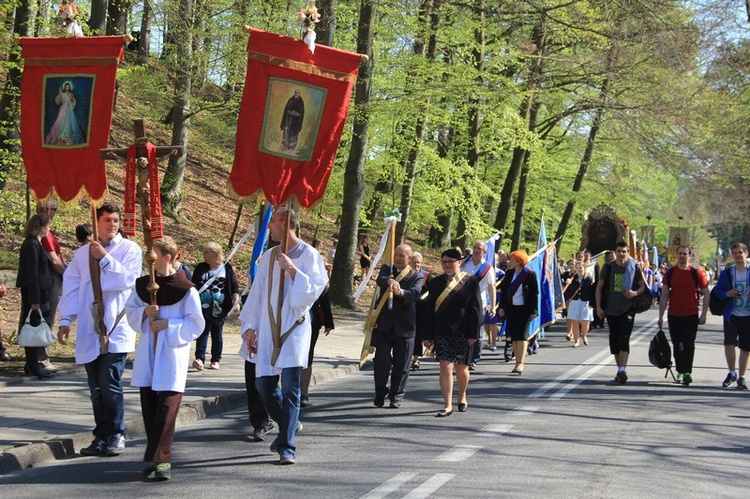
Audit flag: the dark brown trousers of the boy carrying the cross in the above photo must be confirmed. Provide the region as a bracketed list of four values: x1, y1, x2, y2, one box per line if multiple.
[141, 387, 182, 463]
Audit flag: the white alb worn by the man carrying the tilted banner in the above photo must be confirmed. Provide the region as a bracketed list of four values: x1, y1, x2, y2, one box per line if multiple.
[240, 241, 328, 376]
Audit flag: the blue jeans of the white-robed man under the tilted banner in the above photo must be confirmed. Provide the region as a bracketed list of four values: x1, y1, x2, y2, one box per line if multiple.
[255, 367, 302, 454]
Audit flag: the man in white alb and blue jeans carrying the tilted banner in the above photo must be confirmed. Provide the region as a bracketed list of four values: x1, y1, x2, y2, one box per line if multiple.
[240, 208, 328, 464]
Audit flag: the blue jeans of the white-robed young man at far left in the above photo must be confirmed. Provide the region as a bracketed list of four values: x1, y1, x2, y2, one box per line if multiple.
[84, 353, 128, 440]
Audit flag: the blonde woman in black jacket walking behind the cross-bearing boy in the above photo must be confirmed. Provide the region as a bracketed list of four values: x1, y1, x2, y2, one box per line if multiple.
[192, 242, 240, 371]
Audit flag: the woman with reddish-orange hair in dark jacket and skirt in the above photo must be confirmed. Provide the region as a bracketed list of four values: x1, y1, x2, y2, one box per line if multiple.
[497, 250, 539, 376]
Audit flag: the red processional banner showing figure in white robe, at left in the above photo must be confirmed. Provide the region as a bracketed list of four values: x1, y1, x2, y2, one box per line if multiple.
[20, 36, 123, 202]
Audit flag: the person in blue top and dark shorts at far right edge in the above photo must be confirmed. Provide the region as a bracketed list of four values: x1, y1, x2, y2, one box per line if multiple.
[712, 243, 750, 390]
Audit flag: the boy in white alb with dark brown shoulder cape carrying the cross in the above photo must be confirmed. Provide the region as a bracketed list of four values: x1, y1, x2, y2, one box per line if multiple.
[125, 237, 205, 480]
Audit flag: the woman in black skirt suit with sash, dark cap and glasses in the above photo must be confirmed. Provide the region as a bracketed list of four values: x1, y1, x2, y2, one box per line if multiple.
[424, 248, 484, 418]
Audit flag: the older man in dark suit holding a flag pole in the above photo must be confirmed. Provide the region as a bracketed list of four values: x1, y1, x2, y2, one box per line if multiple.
[371, 244, 423, 409]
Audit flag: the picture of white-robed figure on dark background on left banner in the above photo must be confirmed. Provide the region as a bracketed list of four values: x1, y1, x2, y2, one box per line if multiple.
[42, 75, 95, 148]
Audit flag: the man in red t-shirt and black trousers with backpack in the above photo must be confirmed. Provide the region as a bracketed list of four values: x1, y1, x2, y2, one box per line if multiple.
[657, 246, 708, 386]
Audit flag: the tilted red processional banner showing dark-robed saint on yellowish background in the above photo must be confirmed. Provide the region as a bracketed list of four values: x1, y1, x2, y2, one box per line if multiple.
[229, 29, 361, 207]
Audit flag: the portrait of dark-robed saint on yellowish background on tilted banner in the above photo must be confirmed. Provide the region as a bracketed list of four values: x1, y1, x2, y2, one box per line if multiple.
[260, 77, 327, 161]
